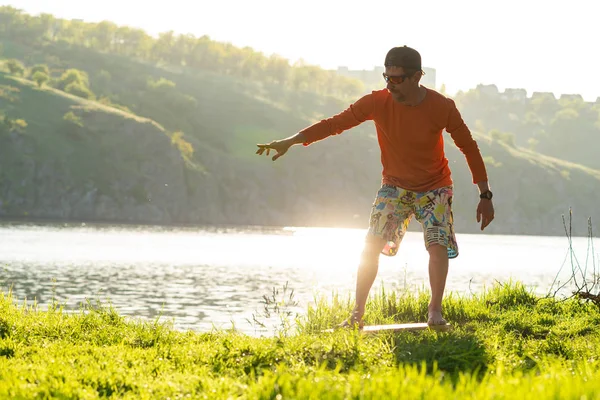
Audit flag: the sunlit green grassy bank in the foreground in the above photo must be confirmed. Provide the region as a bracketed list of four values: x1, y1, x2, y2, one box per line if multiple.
[0, 284, 600, 399]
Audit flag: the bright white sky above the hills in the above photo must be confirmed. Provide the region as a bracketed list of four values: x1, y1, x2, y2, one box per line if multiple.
[0, 0, 600, 101]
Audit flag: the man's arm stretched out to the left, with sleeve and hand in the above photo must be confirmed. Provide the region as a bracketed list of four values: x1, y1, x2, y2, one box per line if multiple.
[256, 94, 374, 161]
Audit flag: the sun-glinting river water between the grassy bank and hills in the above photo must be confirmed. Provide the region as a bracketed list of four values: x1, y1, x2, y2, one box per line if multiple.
[0, 223, 600, 334]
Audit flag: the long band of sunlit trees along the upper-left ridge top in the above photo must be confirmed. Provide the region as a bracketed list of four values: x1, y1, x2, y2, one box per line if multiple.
[0, 7, 362, 101]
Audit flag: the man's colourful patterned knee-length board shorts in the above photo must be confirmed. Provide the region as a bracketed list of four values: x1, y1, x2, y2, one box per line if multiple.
[368, 184, 458, 258]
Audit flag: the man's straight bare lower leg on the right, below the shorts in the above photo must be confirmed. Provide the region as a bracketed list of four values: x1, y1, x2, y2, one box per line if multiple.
[427, 244, 448, 325]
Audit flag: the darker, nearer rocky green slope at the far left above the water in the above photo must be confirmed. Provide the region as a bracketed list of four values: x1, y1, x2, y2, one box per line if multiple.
[0, 74, 195, 222]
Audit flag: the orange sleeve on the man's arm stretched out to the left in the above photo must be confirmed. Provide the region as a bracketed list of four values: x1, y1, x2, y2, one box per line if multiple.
[301, 93, 374, 146]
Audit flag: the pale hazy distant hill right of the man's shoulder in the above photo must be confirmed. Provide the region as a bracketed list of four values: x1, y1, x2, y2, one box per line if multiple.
[455, 85, 600, 169]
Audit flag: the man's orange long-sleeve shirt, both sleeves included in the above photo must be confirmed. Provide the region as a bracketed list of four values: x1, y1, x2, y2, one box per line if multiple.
[301, 88, 487, 192]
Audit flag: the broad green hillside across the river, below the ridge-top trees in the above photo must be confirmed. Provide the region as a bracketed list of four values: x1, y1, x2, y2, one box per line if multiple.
[0, 7, 600, 235]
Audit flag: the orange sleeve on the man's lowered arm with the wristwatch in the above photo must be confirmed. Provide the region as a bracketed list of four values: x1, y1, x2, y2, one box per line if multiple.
[446, 99, 488, 184]
